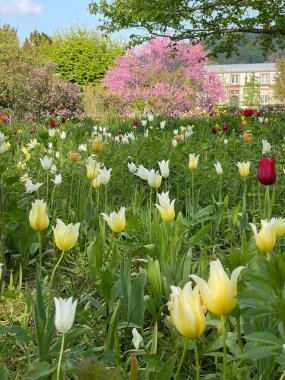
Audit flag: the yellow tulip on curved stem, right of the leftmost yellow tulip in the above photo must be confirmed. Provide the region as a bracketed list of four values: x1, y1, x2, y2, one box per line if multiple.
[52, 219, 80, 252]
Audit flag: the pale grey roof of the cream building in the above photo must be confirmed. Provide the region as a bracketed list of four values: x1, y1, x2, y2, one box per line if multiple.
[208, 63, 277, 73]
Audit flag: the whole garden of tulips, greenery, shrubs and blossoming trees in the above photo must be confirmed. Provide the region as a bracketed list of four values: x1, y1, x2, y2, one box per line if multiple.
[0, 0, 285, 380]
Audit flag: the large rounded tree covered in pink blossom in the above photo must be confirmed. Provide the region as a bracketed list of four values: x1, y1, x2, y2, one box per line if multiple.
[103, 38, 225, 115]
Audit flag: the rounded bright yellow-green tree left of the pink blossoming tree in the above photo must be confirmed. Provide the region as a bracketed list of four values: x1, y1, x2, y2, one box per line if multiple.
[40, 27, 123, 85]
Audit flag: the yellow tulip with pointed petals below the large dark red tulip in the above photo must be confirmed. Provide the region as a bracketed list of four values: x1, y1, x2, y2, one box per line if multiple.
[249, 220, 276, 252]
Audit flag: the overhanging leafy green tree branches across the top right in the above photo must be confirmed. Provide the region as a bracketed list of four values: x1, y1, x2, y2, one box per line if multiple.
[89, 0, 285, 56]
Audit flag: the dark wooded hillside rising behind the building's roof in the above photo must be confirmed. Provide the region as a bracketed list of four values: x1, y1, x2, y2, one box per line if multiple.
[213, 34, 285, 64]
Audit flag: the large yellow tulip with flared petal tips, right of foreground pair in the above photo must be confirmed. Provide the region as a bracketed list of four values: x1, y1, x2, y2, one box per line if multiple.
[190, 260, 244, 315]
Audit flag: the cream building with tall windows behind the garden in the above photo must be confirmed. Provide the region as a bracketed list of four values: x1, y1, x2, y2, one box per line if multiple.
[209, 63, 278, 108]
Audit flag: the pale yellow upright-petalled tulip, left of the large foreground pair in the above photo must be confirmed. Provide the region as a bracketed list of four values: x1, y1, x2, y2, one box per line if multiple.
[168, 282, 206, 339]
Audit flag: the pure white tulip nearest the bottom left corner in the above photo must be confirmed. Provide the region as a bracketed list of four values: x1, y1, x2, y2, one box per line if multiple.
[54, 297, 77, 334]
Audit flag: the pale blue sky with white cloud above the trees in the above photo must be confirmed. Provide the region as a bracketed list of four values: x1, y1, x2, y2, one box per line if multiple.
[0, 0, 130, 42]
